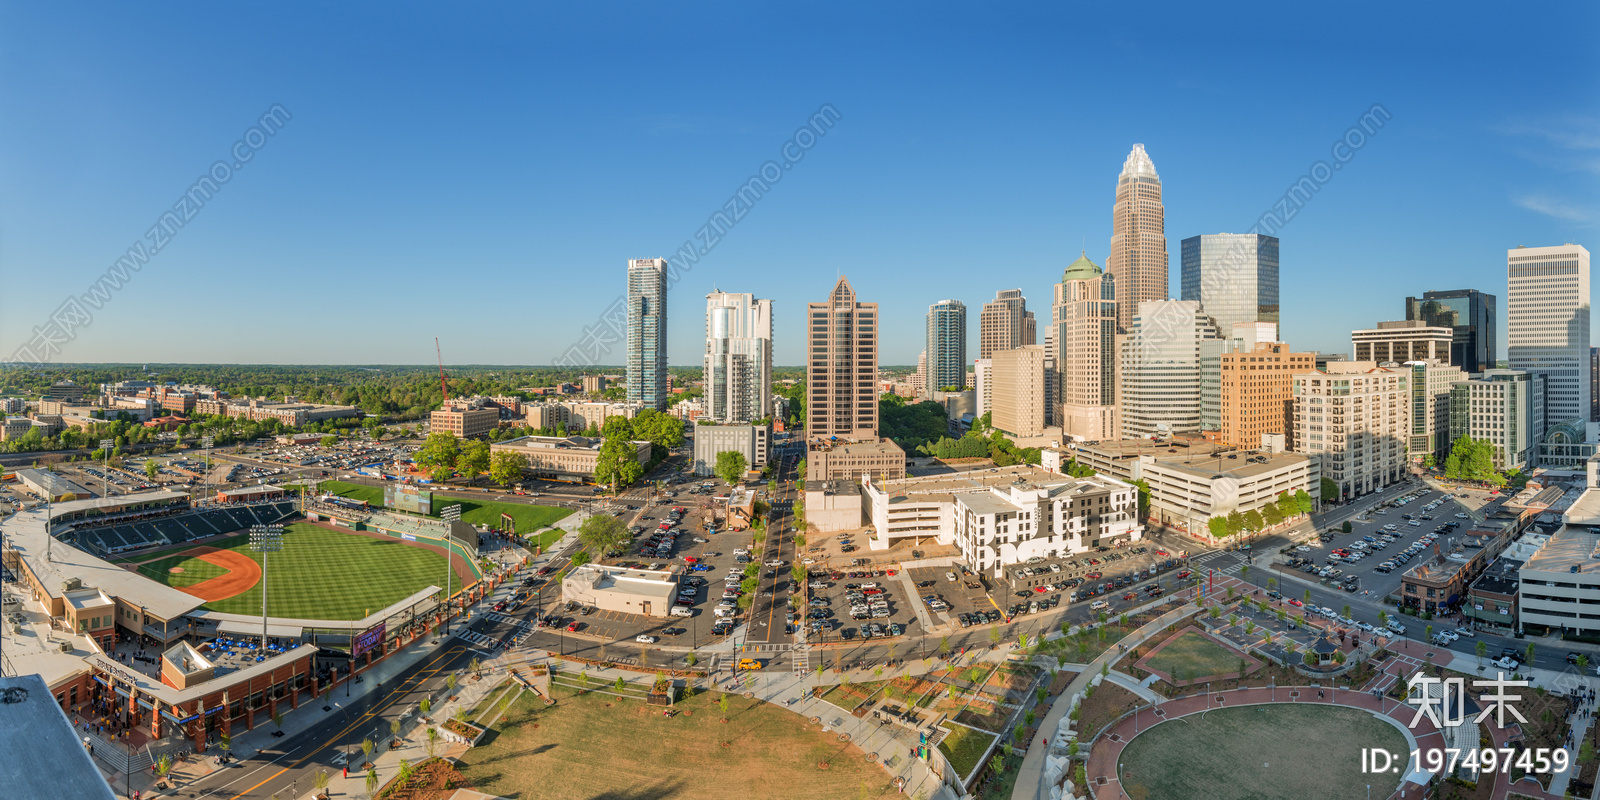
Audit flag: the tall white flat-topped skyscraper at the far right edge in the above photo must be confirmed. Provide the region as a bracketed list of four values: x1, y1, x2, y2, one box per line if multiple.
[1506, 245, 1589, 428]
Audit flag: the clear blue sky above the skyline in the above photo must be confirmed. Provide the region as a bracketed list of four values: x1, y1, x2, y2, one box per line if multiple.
[0, 2, 1600, 365]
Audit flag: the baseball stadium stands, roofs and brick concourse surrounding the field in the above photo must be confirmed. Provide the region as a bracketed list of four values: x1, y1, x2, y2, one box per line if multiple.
[0, 491, 498, 773]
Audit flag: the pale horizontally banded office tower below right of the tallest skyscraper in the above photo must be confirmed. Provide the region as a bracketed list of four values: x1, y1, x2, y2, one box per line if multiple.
[1117, 300, 1219, 438]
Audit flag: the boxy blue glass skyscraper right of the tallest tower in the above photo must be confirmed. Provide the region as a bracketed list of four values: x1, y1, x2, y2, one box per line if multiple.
[1179, 234, 1278, 331]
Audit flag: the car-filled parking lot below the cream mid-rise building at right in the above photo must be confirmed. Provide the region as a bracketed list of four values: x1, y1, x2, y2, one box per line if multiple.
[1275, 488, 1482, 600]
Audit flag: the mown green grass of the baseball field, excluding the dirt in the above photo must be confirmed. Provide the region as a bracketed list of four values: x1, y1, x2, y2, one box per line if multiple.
[139, 523, 466, 619]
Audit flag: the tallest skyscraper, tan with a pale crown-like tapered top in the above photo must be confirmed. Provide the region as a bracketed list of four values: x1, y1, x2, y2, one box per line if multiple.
[1106, 144, 1166, 330]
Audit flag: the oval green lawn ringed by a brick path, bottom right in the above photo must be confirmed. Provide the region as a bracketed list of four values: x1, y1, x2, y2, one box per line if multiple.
[1118, 704, 1406, 800]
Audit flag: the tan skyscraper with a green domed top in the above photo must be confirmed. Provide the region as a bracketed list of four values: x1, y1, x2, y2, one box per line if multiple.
[1045, 254, 1117, 442]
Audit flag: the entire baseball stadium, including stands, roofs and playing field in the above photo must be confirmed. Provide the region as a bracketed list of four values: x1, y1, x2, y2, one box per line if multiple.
[0, 490, 506, 771]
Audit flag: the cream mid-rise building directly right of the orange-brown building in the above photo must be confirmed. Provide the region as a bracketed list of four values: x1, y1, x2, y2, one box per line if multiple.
[1293, 362, 1411, 501]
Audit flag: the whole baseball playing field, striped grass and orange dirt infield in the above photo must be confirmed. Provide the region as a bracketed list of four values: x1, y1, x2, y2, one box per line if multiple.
[123, 522, 470, 619]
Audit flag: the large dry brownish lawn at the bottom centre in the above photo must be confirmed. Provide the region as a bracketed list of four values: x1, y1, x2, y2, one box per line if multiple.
[461, 686, 908, 800]
